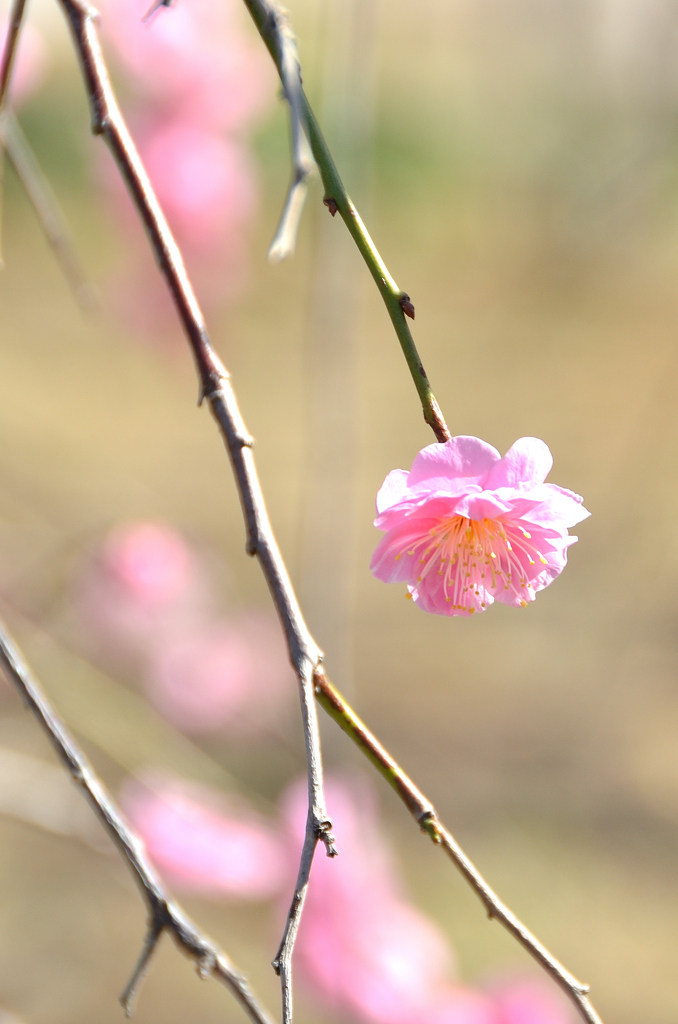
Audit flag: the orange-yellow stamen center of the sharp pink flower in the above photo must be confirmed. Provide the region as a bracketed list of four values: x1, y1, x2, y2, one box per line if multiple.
[397, 515, 547, 613]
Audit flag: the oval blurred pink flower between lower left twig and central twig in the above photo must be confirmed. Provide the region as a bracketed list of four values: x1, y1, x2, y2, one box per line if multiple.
[122, 780, 287, 899]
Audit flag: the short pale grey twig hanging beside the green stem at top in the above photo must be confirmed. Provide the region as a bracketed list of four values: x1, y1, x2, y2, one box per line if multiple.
[268, 4, 313, 263]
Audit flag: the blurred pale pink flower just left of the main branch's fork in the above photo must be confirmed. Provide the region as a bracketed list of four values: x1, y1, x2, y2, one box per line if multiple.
[145, 613, 294, 733]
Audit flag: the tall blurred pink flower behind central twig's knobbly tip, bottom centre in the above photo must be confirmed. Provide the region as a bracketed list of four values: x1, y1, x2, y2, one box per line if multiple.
[283, 779, 462, 1024]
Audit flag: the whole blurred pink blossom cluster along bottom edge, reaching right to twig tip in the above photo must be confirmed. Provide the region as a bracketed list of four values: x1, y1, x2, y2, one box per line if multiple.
[282, 778, 574, 1024]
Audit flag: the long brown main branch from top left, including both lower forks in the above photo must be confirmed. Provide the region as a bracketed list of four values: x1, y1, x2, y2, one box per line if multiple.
[47, 0, 601, 1024]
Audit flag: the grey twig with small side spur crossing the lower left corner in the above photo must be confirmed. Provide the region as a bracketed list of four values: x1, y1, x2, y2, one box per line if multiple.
[0, 622, 272, 1024]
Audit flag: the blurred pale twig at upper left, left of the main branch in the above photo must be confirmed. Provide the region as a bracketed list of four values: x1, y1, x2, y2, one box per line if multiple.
[0, 111, 98, 313]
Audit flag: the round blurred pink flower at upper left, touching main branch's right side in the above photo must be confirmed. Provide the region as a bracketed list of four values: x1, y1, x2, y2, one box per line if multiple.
[137, 120, 256, 253]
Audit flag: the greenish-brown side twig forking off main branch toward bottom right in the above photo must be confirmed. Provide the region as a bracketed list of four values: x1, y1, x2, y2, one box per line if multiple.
[314, 668, 602, 1024]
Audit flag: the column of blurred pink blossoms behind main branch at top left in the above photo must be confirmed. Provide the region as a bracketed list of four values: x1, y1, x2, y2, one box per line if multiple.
[99, 0, 276, 319]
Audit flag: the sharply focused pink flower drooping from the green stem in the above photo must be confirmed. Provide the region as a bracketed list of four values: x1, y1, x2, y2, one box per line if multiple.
[371, 435, 590, 615]
